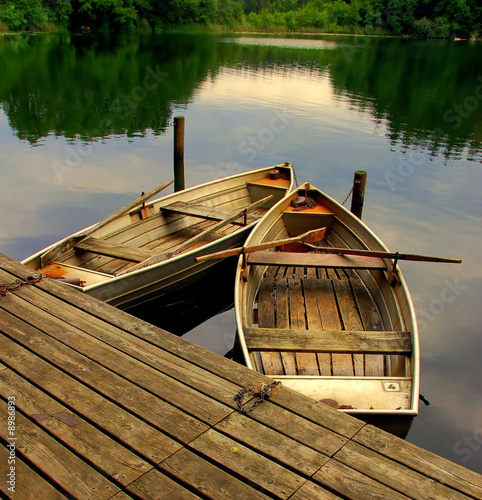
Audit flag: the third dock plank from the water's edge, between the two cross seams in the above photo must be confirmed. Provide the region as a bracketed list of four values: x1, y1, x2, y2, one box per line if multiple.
[215, 413, 328, 476]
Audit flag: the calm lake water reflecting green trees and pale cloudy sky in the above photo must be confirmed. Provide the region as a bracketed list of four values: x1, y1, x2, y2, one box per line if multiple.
[0, 31, 482, 472]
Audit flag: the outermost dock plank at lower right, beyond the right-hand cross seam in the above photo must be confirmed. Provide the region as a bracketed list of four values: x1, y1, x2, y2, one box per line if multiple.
[353, 425, 482, 498]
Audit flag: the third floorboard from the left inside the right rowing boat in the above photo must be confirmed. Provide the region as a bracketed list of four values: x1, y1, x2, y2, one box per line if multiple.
[288, 278, 320, 375]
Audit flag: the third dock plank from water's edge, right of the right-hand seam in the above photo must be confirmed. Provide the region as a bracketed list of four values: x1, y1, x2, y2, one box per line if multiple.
[313, 460, 410, 500]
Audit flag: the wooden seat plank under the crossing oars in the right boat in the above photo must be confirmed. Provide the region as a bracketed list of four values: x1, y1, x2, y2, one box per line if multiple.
[248, 251, 387, 269]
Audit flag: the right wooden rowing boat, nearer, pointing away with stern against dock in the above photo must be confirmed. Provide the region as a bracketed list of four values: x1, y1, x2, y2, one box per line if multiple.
[235, 184, 419, 435]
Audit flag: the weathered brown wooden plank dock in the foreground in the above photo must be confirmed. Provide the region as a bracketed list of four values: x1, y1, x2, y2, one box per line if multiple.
[0, 255, 482, 500]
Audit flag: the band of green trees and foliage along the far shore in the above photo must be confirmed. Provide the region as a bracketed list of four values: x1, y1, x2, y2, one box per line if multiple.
[0, 0, 482, 38]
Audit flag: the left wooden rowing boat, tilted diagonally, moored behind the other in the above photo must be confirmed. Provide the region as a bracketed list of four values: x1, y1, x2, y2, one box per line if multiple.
[23, 164, 293, 309]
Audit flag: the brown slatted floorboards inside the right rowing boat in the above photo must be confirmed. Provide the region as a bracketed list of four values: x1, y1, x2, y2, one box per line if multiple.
[251, 266, 403, 377]
